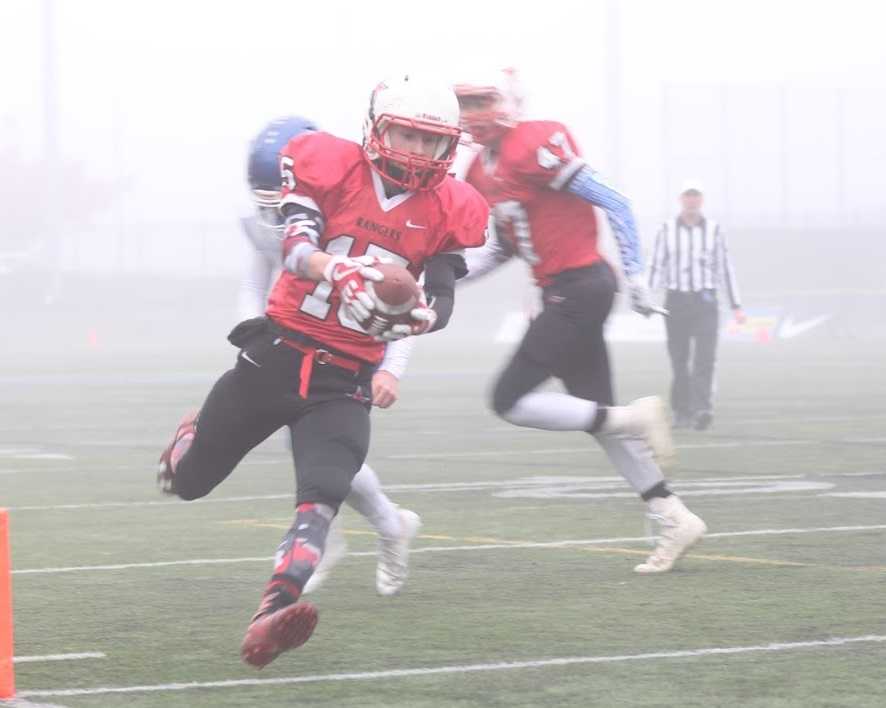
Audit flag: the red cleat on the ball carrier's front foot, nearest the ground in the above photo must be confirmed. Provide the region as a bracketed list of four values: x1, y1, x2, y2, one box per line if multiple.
[240, 602, 317, 669]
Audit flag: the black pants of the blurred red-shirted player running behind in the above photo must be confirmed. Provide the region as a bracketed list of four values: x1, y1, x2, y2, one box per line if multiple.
[492, 261, 617, 415]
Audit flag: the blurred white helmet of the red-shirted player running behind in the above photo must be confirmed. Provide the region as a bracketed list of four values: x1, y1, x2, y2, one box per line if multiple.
[454, 68, 523, 145]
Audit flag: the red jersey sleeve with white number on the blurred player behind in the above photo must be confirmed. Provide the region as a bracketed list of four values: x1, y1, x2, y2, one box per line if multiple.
[501, 121, 585, 202]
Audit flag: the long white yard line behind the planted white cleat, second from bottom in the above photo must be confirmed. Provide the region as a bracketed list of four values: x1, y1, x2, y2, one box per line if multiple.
[12, 524, 886, 575]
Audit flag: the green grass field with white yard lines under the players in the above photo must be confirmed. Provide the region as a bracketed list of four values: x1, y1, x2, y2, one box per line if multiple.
[0, 318, 886, 708]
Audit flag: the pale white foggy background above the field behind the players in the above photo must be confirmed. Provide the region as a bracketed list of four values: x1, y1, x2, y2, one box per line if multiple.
[0, 0, 886, 365]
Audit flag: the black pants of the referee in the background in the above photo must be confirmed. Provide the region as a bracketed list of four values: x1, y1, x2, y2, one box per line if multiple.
[665, 290, 720, 419]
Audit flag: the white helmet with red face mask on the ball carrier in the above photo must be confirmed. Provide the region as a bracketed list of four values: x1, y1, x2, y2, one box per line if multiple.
[363, 75, 461, 191]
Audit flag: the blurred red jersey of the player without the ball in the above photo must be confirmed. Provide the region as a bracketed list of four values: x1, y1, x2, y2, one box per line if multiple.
[465, 121, 601, 286]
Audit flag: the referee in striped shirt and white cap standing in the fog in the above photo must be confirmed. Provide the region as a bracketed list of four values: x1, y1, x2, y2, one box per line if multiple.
[649, 181, 745, 430]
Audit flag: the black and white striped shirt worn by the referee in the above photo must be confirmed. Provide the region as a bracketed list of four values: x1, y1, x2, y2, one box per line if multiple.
[649, 217, 741, 309]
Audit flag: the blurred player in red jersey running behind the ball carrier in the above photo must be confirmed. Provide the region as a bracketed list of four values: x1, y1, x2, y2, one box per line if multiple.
[455, 71, 707, 573]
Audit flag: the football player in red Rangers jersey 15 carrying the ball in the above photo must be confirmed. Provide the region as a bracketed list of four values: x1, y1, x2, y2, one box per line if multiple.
[159, 77, 489, 667]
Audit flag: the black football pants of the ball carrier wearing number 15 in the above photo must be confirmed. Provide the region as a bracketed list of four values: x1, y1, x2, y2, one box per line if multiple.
[175, 320, 371, 509]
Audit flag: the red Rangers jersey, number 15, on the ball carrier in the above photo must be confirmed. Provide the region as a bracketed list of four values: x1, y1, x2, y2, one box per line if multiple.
[267, 133, 489, 364]
